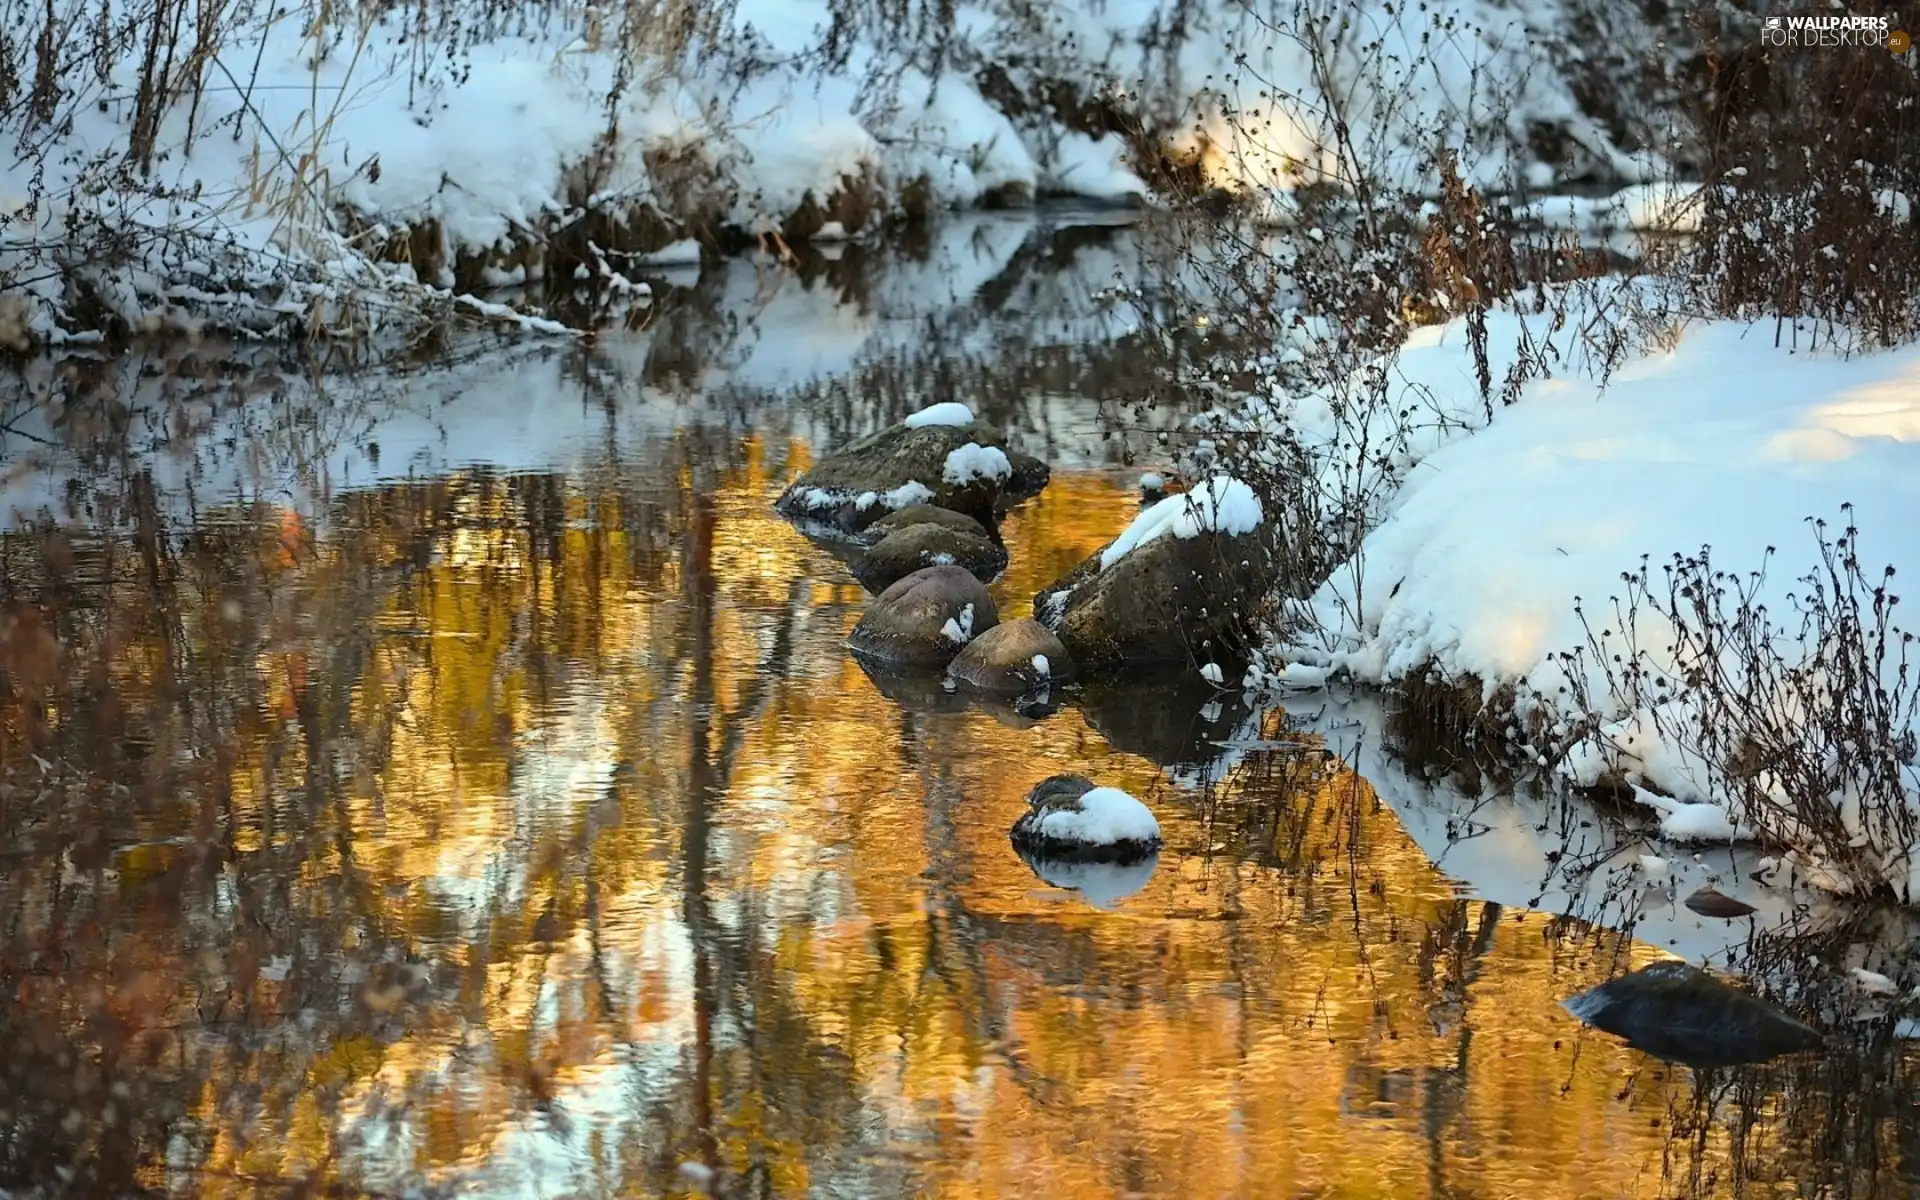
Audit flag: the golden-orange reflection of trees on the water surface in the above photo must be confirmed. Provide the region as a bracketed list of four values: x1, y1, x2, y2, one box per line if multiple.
[10, 440, 1820, 1200]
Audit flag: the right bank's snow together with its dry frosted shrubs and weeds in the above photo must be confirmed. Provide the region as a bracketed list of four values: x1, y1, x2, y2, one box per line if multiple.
[1113, 10, 1920, 900]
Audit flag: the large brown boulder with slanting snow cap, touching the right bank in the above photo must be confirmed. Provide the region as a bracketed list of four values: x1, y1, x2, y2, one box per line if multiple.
[1033, 476, 1277, 676]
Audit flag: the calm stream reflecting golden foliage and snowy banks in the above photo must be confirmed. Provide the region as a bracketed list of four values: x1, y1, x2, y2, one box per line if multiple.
[0, 211, 1920, 1200]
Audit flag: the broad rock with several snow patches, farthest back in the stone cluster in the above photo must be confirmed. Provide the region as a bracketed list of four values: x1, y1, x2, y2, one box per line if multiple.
[774, 401, 1048, 534]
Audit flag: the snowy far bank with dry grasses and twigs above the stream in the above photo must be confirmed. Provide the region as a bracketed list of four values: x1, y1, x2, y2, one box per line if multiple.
[0, 0, 1674, 346]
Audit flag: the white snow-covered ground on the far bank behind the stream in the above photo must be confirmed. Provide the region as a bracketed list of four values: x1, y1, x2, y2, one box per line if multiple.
[0, 0, 1659, 340]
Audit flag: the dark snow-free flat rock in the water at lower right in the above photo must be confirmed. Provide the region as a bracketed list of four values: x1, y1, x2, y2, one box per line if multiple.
[1567, 962, 1824, 1068]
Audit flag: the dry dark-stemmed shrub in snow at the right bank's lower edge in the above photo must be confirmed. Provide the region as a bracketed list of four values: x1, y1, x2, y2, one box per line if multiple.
[1563, 509, 1920, 902]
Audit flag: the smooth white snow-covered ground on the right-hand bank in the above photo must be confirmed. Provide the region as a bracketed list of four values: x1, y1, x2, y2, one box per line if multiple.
[1250, 284, 1920, 900]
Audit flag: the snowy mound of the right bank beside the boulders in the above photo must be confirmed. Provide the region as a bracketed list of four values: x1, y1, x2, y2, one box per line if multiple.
[1256, 297, 1920, 900]
